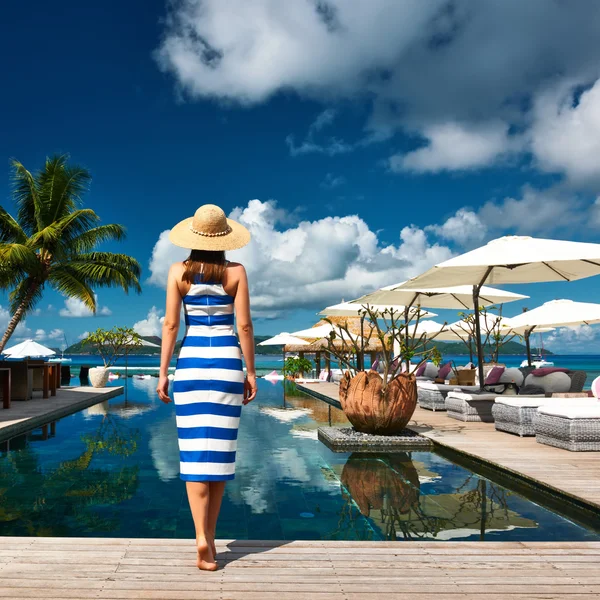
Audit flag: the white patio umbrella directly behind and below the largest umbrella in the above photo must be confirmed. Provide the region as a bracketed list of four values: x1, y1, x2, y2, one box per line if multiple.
[351, 281, 529, 316]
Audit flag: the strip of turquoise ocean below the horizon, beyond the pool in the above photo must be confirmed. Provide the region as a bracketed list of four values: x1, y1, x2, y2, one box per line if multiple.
[58, 354, 600, 388]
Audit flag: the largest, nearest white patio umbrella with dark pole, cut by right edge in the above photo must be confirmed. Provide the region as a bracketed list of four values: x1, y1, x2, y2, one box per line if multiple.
[402, 236, 600, 383]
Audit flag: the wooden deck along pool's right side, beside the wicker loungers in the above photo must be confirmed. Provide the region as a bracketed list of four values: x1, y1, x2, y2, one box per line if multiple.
[298, 383, 600, 510]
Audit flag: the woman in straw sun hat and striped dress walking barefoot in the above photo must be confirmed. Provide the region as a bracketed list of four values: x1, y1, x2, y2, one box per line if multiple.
[156, 204, 256, 571]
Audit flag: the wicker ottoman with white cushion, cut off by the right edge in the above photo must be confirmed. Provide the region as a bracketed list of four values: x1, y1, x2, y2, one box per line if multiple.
[533, 398, 600, 452]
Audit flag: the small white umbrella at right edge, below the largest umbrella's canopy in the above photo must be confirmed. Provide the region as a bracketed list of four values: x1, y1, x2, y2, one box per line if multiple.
[511, 300, 600, 364]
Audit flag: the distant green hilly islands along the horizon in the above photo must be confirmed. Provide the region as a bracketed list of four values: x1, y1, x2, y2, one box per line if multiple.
[64, 335, 553, 356]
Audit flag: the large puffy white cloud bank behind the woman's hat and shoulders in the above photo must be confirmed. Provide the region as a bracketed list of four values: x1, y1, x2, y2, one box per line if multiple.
[150, 200, 451, 317]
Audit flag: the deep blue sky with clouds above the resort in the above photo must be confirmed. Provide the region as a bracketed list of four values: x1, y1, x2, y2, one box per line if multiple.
[0, 0, 600, 353]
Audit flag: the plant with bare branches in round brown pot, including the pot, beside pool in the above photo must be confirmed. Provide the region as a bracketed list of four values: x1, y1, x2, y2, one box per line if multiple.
[328, 306, 441, 435]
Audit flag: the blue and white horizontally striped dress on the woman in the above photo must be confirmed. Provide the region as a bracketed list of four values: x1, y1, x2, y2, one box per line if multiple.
[173, 283, 244, 481]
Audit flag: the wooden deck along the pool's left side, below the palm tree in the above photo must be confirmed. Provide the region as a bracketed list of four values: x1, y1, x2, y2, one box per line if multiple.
[0, 386, 123, 441]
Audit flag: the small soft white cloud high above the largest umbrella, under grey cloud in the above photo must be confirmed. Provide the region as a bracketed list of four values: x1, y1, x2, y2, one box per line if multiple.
[390, 122, 519, 173]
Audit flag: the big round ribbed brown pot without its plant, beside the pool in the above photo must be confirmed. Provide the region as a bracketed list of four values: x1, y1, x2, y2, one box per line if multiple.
[340, 371, 417, 435]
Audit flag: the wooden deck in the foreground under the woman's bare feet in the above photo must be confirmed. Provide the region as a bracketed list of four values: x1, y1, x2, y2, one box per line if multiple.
[0, 537, 600, 600]
